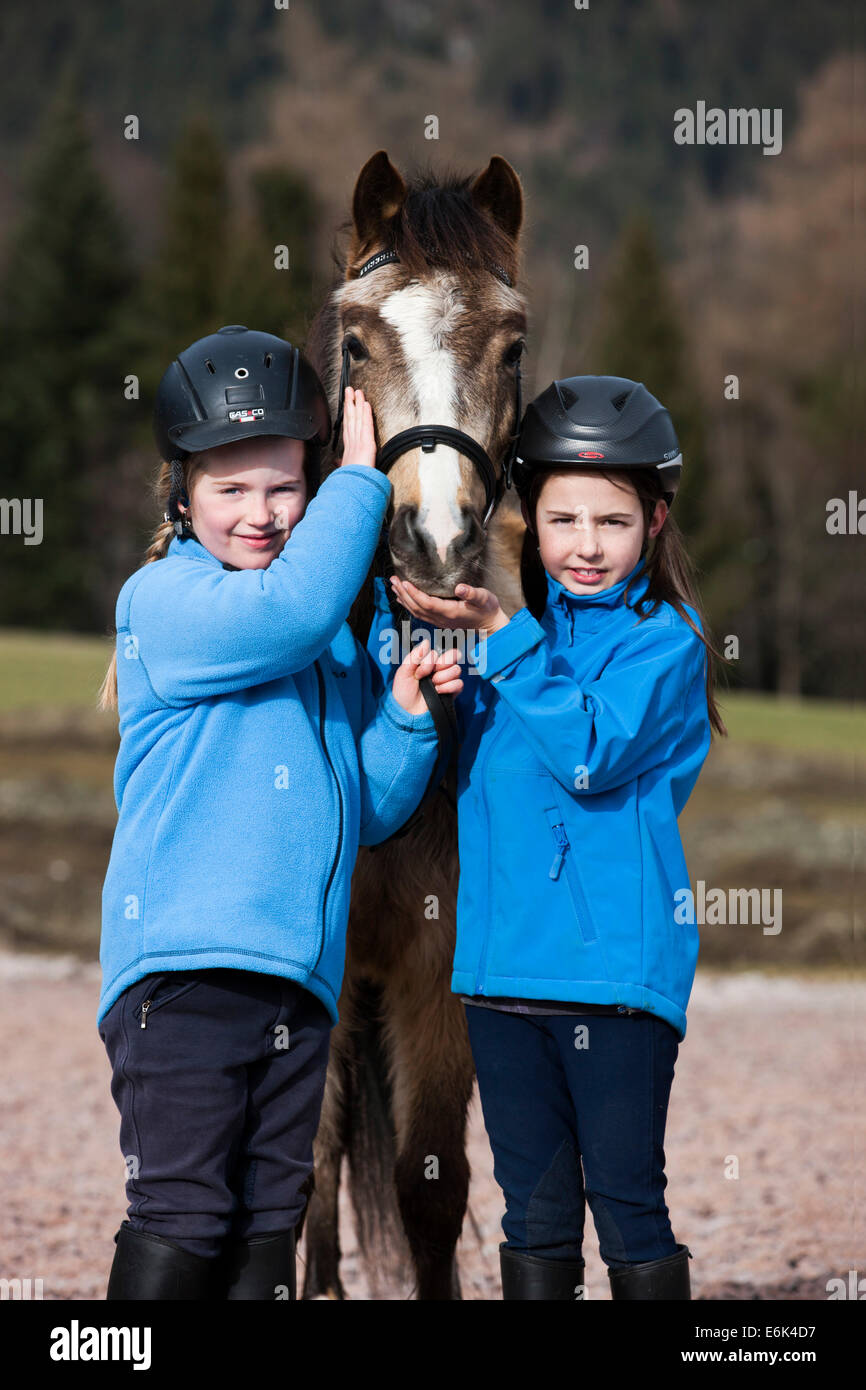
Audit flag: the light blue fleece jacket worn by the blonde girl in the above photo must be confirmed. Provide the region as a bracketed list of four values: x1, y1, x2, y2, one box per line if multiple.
[97, 466, 436, 1024]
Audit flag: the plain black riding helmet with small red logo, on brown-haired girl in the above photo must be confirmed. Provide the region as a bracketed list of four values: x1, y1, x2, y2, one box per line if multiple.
[509, 377, 683, 507]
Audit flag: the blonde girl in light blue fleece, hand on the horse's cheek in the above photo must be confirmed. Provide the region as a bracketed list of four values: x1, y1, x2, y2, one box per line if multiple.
[97, 325, 461, 1300]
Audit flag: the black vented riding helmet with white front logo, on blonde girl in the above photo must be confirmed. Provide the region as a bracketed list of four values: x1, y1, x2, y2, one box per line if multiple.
[153, 324, 331, 530]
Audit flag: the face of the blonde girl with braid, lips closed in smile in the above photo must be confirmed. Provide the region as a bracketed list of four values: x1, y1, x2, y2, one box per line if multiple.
[182, 435, 307, 570]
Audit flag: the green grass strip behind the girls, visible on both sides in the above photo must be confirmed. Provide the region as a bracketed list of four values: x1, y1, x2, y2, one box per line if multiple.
[0, 628, 866, 755]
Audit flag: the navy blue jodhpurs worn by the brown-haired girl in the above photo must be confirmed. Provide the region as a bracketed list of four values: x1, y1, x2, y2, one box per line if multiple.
[464, 1005, 680, 1269]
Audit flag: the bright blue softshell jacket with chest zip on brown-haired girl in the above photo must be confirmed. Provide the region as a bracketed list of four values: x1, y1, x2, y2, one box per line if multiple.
[368, 560, 710, 1038]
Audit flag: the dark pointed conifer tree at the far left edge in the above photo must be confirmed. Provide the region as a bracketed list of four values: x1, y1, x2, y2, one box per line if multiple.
[0, 84, 131, 628]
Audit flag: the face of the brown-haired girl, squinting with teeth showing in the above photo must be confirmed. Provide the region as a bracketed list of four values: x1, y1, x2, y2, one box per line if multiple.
[523, 471, 667, 594]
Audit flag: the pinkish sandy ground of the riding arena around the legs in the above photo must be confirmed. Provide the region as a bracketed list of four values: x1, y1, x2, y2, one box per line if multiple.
[0, 954, 866, 1300]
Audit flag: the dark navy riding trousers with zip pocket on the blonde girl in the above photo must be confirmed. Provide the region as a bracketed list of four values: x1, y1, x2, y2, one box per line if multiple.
[99, 969, 332, 1257]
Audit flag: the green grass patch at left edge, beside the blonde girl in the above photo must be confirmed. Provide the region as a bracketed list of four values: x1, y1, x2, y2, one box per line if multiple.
[0, 628, 114, 712]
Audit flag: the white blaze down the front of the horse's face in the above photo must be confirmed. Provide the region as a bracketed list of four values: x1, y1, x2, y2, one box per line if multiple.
[379, 275, 463, 562]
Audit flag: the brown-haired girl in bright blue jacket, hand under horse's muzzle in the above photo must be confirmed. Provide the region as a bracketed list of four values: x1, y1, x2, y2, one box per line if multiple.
[389, 377, 727, 1300]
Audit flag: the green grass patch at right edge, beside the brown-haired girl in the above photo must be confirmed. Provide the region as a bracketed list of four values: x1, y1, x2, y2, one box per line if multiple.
[717, 691, 866, 758]
